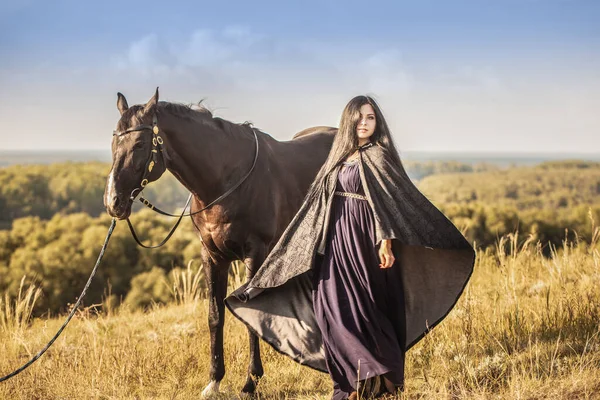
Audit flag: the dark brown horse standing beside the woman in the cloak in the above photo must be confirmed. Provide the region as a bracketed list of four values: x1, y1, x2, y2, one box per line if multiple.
[104, 89, 336, 395]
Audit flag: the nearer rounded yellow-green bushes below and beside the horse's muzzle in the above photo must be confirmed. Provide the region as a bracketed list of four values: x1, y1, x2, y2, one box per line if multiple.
[0, 210, 204, 314]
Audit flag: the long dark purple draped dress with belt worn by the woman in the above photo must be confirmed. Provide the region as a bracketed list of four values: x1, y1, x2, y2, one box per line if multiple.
[313, 160, 405, 400]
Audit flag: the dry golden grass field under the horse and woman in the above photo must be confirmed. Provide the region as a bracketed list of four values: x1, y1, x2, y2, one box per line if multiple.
[0, 229, 600, 399]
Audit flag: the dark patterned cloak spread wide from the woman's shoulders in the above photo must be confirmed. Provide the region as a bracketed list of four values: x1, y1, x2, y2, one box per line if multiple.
[225, 143, 475, 372]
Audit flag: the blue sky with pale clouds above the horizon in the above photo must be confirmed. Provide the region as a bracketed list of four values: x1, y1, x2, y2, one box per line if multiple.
[0, 0, 600, 153]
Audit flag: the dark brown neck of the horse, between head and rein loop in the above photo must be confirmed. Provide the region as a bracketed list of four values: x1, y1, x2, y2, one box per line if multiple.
[158, 109, 254, 203]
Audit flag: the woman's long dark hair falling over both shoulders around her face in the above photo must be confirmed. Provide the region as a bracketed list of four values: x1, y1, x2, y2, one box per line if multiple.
[307, 95, 404, 197]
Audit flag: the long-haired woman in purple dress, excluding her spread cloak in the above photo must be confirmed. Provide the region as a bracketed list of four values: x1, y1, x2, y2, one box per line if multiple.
[313, 96, 404, 400]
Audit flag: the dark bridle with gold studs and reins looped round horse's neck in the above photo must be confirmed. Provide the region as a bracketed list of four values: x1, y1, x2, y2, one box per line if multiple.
[113, 113, 259, 249]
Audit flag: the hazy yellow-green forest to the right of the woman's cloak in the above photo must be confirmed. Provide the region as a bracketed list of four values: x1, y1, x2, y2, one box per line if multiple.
[418, 161, 600, 247]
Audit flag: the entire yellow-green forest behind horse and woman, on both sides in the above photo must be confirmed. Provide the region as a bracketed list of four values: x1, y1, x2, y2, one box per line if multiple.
[0, 161, 600, 314]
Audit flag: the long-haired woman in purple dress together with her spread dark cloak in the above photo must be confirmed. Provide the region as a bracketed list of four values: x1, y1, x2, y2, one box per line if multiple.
[226, 96, 474, 400]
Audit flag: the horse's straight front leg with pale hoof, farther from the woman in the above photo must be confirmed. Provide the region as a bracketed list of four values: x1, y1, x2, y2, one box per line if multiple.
[202, 255, 230, 397]
